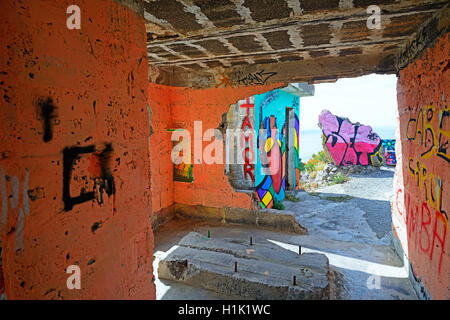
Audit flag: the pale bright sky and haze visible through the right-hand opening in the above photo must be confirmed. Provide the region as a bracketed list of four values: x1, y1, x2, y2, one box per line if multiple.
[300, 74, 397, 161]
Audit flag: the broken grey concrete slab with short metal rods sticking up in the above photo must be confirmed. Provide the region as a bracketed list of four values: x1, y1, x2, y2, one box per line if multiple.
[158, 232, 333, 300]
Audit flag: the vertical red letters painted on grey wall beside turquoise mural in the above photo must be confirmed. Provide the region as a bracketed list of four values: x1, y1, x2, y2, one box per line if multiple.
[239, 98, 255, 182]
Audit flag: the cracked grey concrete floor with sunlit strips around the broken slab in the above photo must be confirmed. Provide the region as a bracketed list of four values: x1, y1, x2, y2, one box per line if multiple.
[153, 168, 417, 300]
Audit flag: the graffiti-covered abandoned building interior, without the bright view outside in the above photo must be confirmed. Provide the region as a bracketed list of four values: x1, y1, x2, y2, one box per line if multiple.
[0, 0, 450, 300]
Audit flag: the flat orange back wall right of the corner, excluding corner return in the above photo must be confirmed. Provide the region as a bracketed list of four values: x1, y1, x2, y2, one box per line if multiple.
[172, 84, 280, 209]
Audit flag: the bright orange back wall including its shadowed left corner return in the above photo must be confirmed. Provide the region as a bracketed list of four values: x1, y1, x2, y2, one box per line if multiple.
[149, 83, 280, 212]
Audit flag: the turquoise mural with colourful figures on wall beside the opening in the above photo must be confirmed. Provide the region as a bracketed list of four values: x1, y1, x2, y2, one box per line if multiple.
[255, 90, 300, 208]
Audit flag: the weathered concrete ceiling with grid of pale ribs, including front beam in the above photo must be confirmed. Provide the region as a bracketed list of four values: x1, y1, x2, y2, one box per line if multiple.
[144, 0, 448, 87]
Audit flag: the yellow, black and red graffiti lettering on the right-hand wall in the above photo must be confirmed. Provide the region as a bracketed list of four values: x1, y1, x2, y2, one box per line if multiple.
[393, 106, 450, 275]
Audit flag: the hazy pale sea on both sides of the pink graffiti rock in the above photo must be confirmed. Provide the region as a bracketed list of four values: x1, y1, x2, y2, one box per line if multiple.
[300, 126, 396, 162]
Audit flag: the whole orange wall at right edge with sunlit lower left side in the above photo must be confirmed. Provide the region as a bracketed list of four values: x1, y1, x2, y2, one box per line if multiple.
[392, 34, 450, 299]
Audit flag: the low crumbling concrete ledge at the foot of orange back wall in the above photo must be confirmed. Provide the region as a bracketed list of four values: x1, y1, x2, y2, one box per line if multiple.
[173, 203, 308, 235]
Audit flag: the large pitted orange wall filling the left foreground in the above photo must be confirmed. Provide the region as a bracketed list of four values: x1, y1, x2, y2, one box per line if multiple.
[0, 0, 155, 299]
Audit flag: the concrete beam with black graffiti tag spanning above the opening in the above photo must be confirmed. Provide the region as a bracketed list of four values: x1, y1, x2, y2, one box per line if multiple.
[150, 52, 397, 88]
